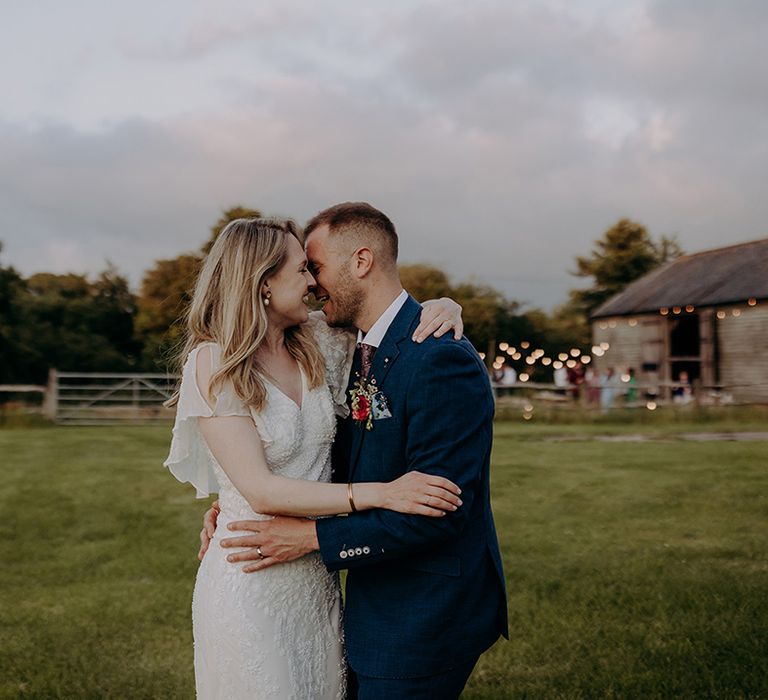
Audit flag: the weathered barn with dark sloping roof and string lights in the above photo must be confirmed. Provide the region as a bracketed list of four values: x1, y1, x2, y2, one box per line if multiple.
[592, 239, 768, 403]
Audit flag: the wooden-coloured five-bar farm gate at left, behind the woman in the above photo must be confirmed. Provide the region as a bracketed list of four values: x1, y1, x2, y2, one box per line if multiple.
[46, 370, 179, 425]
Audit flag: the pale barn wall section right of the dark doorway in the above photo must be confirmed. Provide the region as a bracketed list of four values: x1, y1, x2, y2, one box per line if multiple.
[717, 304, 768, 403]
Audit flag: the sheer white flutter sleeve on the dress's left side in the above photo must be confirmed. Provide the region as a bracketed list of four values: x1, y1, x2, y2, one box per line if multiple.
[163, 343, 251, 498]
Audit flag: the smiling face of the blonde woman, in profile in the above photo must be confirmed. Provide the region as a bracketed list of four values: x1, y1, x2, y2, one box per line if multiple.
[265, 236, 315, 328]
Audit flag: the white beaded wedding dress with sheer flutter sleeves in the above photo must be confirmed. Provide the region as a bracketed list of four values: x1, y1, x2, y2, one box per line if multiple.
[165, 314, 354, 700]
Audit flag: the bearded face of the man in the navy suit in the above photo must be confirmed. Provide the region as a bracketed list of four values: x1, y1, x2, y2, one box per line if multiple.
[306, 225, 363, 327]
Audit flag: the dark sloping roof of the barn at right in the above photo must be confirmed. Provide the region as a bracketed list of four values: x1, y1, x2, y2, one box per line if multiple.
[592, 238, 768, 318]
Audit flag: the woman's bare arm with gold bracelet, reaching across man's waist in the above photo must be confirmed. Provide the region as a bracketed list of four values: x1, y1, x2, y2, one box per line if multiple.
[195, 347, 461, 517]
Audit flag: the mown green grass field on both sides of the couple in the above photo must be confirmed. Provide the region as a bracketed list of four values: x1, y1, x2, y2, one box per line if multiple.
[0, 421, 768, 699]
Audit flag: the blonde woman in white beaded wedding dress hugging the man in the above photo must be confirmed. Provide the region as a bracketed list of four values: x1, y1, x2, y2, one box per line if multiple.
[165, 219, 460, 700]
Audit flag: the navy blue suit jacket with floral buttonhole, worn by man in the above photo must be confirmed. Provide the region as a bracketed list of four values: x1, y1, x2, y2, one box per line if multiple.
[317, 297, 507, 678]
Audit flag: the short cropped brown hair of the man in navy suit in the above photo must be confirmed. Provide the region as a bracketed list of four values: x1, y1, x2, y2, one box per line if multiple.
[304, 202, 398, 267]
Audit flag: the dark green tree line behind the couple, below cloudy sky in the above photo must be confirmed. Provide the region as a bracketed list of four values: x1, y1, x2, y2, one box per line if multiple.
[0, 206, 681, 384]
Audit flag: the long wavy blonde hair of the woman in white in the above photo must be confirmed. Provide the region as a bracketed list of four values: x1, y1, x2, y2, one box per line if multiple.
[166, 219, 325, 411]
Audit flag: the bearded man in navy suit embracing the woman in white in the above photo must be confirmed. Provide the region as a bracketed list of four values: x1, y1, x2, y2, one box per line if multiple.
[212, 203, 507, 700]
